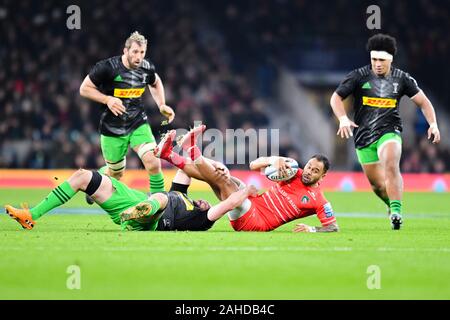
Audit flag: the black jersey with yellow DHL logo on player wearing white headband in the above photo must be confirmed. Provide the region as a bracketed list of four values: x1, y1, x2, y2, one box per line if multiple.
[336, 65, 420, 148]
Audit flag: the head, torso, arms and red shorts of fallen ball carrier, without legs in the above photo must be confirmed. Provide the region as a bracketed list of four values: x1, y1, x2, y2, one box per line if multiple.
[228, 155, 338, 232]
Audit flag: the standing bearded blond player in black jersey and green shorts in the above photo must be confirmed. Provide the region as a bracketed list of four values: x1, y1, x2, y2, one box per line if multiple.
[80, 31, 175, 203]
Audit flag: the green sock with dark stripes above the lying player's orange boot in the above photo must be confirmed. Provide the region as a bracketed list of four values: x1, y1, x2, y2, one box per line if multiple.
[30, 181, 76, 220]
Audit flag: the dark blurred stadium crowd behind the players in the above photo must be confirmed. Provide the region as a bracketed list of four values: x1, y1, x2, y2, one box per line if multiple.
[0, 0, 450, 172]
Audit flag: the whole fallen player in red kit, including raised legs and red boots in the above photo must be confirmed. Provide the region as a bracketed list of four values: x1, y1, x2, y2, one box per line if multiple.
[151, 125, 338, 232]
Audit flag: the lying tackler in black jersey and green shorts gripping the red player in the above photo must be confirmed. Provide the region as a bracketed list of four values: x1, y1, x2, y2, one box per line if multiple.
[5, 131, 256, 231]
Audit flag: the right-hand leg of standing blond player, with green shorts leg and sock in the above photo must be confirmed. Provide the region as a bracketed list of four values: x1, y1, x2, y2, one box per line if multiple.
[130, 123, 164, 193]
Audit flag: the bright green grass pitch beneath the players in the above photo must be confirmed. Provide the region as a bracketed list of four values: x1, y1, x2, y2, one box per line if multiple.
[0, 189, 450, 300]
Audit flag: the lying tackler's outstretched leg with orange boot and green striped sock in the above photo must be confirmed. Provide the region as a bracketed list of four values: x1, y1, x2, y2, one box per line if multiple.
[5, 169, 108, 229]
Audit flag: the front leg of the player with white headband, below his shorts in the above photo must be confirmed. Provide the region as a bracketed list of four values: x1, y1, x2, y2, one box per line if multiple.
[378, 139, 403, 230]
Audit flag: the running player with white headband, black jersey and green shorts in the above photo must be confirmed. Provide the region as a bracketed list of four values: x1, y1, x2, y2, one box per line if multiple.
[330, 34, 440, 230]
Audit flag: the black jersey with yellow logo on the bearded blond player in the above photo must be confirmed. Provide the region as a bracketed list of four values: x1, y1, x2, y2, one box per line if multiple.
[89, 56, 156, 136]
